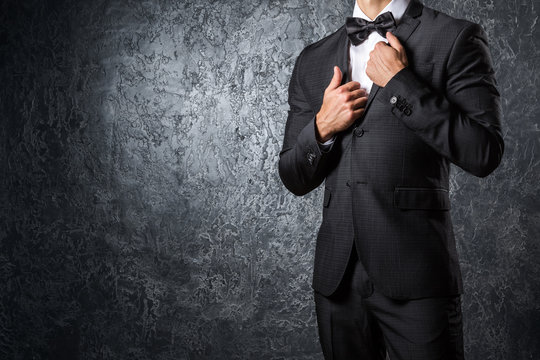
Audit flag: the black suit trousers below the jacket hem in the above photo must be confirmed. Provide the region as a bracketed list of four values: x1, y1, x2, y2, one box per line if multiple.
[314, 242, 463, 360]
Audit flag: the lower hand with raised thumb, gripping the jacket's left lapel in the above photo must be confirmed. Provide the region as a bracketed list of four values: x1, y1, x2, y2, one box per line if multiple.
[315, 66, 367, 142]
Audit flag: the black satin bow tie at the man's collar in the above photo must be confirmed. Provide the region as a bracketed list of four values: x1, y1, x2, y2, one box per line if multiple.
[345, 11, 396, 46]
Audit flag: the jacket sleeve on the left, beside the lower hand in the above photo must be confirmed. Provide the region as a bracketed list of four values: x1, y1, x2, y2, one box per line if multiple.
[279, 51, 331, 195]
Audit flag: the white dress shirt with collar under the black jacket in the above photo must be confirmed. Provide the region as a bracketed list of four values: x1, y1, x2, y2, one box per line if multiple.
[319, 0, 410, 152]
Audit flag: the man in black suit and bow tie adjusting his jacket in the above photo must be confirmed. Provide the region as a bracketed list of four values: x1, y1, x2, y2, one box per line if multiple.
[279, 0, 504, 360]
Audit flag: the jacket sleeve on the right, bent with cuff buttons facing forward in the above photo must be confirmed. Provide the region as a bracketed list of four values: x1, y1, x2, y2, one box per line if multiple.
[378, 23, 504, 177]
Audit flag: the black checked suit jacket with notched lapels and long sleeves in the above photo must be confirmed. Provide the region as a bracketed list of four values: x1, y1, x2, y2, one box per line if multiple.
[279, 0, 504, 299]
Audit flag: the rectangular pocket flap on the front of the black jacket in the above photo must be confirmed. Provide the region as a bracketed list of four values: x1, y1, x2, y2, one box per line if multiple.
[394, 187, 450, 210]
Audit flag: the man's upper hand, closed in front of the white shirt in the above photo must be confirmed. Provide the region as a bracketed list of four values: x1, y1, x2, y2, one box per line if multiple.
[366, 32, 409, 87]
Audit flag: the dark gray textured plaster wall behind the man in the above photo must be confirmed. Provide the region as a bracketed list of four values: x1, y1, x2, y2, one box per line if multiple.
[0, 0, 540, 360]
